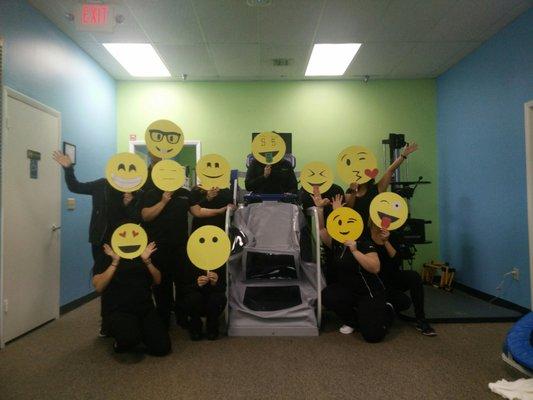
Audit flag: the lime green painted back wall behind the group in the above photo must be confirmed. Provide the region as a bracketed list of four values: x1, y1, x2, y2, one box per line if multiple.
[117, 80, 439, 268]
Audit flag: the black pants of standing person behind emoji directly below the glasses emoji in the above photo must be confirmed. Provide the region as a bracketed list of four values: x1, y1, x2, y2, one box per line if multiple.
[152, 243, 187, 328]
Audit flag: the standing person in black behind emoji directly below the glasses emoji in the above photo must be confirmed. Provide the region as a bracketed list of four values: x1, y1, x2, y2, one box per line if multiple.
[141, 188, 231, 327]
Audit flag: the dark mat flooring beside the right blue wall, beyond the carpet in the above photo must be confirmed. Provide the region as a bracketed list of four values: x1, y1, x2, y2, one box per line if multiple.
[404, 286, 522, 322]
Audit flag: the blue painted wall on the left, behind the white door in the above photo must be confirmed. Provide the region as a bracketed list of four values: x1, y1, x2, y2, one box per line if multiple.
[0, 0, 116, 305]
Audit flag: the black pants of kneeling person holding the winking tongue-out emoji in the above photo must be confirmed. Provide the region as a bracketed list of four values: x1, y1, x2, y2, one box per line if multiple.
[385, 271, 426, 319]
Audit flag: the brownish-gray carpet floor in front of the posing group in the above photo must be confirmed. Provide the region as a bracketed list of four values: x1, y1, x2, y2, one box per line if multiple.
[0, 300, 520, 400]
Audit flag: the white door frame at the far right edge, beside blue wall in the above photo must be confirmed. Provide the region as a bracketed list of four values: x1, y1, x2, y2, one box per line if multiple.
[524, 100, 533, 309]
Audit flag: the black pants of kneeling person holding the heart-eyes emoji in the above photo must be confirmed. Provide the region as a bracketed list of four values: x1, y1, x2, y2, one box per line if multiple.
[104, 306, 171, 357]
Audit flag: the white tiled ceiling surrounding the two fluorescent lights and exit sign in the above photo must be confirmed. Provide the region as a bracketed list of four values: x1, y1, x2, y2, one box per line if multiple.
[29, 0, 533, 80]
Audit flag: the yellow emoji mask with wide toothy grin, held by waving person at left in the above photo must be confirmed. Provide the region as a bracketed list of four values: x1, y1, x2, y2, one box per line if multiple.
[105, 153, 148, 193]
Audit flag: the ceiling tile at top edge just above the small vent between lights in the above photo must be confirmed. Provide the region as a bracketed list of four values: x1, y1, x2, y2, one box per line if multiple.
[258, 0, 322, 46]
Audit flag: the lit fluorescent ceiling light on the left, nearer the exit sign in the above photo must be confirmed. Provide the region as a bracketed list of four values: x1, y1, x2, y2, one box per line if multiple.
[103, 43, 170, 78]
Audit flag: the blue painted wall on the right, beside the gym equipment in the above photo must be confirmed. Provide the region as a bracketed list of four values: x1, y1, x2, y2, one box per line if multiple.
[437, 9, 533, 308]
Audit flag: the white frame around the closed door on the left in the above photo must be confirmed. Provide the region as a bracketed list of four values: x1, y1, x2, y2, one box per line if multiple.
[0, 86, 62, 349]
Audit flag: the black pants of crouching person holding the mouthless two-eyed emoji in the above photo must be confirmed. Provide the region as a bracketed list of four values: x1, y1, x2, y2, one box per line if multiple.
[182, 288, 226, 334]
